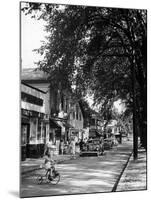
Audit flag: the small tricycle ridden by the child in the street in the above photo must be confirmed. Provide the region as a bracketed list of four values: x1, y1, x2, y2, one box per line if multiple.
[36, 160, 60, 185]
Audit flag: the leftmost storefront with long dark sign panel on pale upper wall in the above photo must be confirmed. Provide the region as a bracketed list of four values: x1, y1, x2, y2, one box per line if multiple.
[21, 84, 49, 160]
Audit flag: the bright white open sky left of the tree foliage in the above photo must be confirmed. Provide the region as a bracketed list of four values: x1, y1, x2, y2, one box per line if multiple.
[21, 9, 46, 68]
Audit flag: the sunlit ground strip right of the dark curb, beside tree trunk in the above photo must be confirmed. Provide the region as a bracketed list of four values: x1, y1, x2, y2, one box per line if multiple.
[116, 148, 147, 191]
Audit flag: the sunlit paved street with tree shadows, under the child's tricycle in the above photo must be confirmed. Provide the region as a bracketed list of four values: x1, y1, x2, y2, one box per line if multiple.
[21, 138, 132, 197]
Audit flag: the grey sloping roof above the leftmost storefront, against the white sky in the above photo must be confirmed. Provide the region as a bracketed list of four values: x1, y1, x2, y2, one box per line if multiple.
[21, 68, 48, 81]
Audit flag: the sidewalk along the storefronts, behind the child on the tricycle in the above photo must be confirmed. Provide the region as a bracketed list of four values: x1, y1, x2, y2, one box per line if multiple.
[20, 155, 78, 175]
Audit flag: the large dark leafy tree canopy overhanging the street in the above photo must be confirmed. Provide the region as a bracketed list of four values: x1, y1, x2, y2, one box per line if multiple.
[23, 3, 147, 148]
